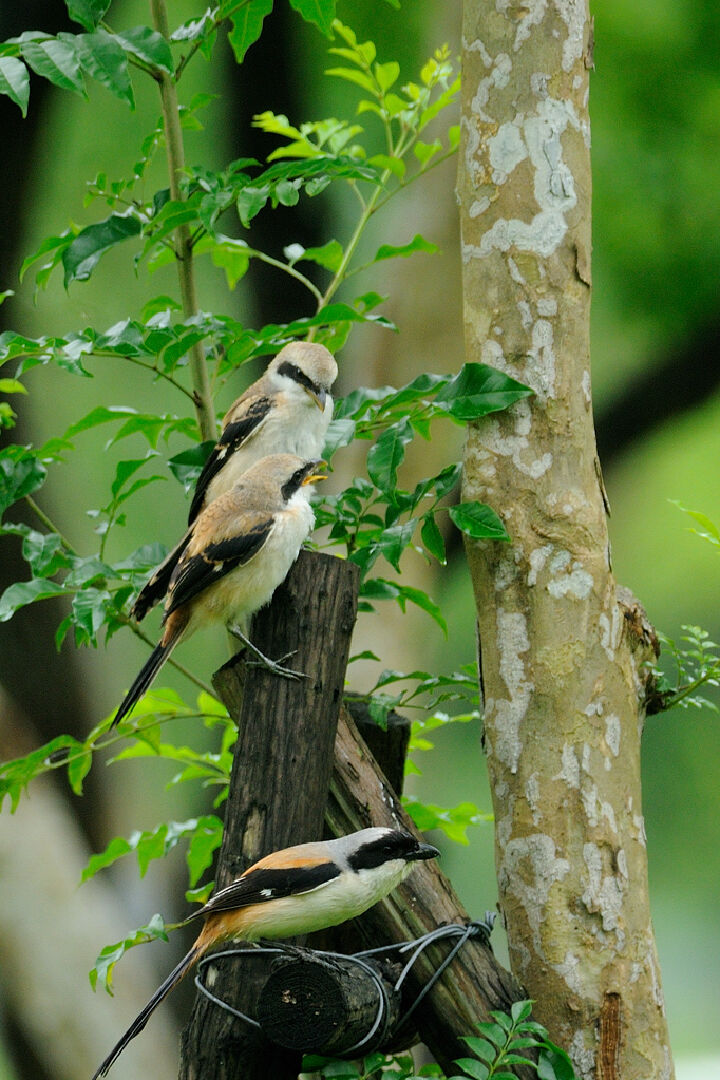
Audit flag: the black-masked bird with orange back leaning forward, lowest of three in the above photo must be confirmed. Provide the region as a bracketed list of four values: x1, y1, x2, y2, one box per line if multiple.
[93, 828, 439, 1080]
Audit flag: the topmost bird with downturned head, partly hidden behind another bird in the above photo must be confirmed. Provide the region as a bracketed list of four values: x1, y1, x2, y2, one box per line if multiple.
[131, 341, 338, 622]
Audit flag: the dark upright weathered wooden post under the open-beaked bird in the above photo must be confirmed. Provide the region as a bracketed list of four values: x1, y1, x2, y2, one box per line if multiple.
[179, 551, 357, 1080]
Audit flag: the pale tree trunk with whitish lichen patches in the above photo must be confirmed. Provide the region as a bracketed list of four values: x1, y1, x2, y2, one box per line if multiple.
[459, 8, 673, 1080]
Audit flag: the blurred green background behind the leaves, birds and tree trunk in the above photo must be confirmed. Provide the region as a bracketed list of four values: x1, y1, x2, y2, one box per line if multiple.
[0, 0, 720, 1080]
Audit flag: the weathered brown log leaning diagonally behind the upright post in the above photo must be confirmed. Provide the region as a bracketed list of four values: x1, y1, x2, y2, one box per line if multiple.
[326, 708, 524, 1075]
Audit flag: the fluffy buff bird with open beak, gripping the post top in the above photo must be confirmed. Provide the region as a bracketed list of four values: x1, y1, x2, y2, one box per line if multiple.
[110, 454, 325, 729]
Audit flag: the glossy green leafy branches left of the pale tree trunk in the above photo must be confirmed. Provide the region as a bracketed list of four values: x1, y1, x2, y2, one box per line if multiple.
[0, 6, 539, 1062]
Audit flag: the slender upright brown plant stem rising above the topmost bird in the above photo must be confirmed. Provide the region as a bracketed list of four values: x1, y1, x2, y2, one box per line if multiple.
[150, 0, 217, 440]
